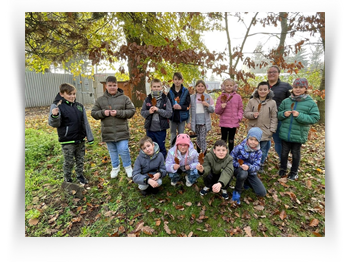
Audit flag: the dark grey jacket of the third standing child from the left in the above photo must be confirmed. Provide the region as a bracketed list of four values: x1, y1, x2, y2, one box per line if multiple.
[141, 93, 173, 131]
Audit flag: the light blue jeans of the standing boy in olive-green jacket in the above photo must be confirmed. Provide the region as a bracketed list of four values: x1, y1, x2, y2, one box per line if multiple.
[106, 140, 131, 168]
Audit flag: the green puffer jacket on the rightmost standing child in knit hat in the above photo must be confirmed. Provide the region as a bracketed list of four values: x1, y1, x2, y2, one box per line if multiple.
[278, 95, 320, 144]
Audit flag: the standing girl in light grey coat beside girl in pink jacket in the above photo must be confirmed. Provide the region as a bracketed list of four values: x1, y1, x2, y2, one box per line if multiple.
[187, 80, 215, 154]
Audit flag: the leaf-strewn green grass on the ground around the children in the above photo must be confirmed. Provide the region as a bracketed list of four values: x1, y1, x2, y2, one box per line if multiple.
[25, 109, 325, 237]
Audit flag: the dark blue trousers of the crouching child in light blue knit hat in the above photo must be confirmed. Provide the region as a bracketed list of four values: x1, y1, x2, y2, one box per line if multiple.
[233, 167, 266, 197]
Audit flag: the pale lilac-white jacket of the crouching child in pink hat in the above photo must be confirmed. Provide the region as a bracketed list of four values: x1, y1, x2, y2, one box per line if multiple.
[165, 141, 199, 173]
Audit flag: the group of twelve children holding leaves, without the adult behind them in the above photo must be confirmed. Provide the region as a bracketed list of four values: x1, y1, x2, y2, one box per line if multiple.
[49, 69, 319, 204]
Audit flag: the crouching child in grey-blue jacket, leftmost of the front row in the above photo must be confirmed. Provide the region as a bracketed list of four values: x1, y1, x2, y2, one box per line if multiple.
[132, 136, 166, 196]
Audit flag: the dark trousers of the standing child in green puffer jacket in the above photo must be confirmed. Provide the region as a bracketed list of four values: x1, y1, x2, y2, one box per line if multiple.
[280, 140, 301, 173]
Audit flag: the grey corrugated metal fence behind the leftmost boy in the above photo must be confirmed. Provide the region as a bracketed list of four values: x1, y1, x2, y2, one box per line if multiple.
[25, 72, 95, 108]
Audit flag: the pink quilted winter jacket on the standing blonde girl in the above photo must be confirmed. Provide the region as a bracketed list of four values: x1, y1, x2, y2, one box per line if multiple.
[215, 92, 243, 128]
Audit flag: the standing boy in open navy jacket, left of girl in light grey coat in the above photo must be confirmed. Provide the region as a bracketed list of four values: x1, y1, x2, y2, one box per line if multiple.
[167, 72, 191, 146]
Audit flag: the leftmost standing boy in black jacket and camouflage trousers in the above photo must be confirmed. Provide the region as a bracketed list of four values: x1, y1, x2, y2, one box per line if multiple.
[49, 83, 94, 184]
